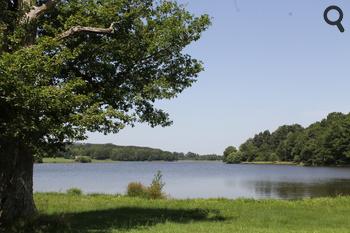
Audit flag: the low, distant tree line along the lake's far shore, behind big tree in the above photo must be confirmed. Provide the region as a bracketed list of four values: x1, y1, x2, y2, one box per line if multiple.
[54, 143, 223, 161]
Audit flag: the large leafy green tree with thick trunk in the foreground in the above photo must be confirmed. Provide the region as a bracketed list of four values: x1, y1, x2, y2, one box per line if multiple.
[0, 0, 210, 222]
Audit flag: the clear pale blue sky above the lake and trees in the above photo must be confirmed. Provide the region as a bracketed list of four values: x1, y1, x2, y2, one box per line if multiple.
[88, 0, 350, 154]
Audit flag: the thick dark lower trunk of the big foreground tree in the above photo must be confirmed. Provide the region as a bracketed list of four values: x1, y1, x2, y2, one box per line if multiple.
[0, 139, 36, 226]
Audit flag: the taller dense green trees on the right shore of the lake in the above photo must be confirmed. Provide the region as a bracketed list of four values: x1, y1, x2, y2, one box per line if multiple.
[224, 113, 350, 166]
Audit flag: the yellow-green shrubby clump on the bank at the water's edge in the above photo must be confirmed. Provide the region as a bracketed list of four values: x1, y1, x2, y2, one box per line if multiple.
[126, 171, 166, 199]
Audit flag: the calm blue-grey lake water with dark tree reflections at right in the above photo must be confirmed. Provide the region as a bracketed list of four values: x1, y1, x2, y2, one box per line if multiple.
[34, 162, 350, 199]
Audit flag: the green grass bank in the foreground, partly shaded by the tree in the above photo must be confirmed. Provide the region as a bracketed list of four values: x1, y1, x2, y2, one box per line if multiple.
[8, 193, 350, 233]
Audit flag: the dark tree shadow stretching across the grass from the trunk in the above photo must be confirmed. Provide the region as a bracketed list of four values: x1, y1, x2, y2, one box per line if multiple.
[6, 207, 226, 233]
